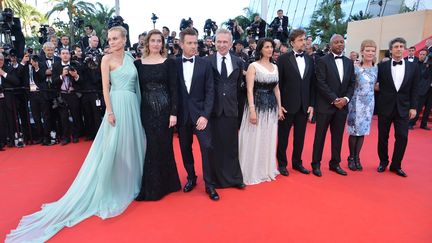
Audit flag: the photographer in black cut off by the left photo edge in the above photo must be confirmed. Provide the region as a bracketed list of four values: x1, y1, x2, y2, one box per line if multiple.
[0, 53, 19, 147]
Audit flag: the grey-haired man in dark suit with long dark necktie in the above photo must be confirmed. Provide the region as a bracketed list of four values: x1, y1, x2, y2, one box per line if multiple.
[209, 29, 245, 189]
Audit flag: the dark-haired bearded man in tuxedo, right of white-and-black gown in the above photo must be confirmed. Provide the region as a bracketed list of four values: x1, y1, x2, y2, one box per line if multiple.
[277, 29, 316, 176]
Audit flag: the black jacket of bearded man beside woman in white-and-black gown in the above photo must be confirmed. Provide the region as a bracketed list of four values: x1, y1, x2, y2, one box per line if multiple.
[277, 51, 316, 114]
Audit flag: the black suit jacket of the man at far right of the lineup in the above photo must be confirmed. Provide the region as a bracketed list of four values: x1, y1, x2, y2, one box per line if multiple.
[377, 60, 420, 117]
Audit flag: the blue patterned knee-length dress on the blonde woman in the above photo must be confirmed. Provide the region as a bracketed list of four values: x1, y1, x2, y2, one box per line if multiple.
[347, 66, 378, 136]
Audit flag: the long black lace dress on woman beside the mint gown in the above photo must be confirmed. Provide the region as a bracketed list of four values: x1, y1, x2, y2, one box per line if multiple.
[135, 59, 181, 201]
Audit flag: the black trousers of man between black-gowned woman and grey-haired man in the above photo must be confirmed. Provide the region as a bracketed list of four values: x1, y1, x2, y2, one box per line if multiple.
[178, 118, 215, 188]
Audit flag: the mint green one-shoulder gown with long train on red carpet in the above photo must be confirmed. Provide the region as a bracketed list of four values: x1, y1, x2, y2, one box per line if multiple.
[6, 53, 146, 242]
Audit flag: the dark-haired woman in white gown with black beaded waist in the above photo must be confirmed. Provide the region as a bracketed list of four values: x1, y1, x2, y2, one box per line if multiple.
[239, 38, 283, 185]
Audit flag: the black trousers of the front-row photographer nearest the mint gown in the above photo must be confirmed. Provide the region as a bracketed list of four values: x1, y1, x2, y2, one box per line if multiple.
[59, 93, 83, 139]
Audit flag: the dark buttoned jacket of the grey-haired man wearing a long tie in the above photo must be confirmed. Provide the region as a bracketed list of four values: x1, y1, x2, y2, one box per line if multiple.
[208, 53, 243, 117]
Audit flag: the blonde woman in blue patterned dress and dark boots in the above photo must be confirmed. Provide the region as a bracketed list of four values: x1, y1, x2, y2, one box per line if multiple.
[347, 40, 378, 171]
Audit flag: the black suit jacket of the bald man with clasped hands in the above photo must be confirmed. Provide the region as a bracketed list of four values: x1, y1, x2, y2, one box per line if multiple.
[315, 53, 355, 114]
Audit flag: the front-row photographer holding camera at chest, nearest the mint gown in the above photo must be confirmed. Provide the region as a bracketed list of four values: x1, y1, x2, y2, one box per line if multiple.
[52, 49, 83, 145]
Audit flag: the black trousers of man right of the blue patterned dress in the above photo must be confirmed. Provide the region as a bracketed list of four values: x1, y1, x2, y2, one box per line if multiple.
[378, 106, 409, 169]
